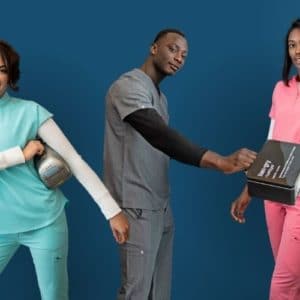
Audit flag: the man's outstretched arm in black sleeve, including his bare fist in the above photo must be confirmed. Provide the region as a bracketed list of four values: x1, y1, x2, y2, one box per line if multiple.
[124, 108, 256, 173]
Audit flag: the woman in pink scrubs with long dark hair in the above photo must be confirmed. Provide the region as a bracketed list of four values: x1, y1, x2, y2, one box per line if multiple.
[231, 19, 300, 300]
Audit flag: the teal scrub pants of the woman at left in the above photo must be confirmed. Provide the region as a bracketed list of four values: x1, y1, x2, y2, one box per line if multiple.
[0, 212, 68, 300]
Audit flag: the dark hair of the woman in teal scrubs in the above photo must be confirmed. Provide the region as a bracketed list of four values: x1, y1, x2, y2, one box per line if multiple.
[0, 40, 20, 91]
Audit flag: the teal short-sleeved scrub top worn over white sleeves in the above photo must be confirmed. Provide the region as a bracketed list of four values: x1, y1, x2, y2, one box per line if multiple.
[0, 93, 67, 234]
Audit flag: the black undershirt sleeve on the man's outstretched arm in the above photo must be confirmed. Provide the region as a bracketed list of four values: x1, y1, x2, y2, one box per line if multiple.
[124, 108, 207, 167]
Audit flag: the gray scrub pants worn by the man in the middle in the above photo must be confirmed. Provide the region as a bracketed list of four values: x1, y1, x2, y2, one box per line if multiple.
[117, 205, 174, 300]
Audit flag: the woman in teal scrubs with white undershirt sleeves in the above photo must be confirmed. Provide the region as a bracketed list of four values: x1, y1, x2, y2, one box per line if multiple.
[0, 41, 128, 300]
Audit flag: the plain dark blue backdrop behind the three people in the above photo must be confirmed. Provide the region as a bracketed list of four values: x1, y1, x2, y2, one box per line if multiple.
[0, 0, 300, 300]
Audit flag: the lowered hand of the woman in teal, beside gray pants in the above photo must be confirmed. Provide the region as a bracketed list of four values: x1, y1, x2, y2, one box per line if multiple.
[109, 212, 129, 244]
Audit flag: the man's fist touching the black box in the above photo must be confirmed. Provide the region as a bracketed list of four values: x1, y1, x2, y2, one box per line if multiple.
[219, 148, 256, 174]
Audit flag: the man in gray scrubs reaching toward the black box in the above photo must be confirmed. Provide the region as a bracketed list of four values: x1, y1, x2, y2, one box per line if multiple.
[104, 29, 256, 300]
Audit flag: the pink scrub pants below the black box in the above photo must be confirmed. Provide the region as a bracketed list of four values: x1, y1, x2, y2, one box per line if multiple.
[265, 198, 300, 300]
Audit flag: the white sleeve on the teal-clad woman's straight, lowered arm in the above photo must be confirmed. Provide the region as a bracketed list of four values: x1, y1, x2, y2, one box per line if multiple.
[38, 119, 121, 219]
